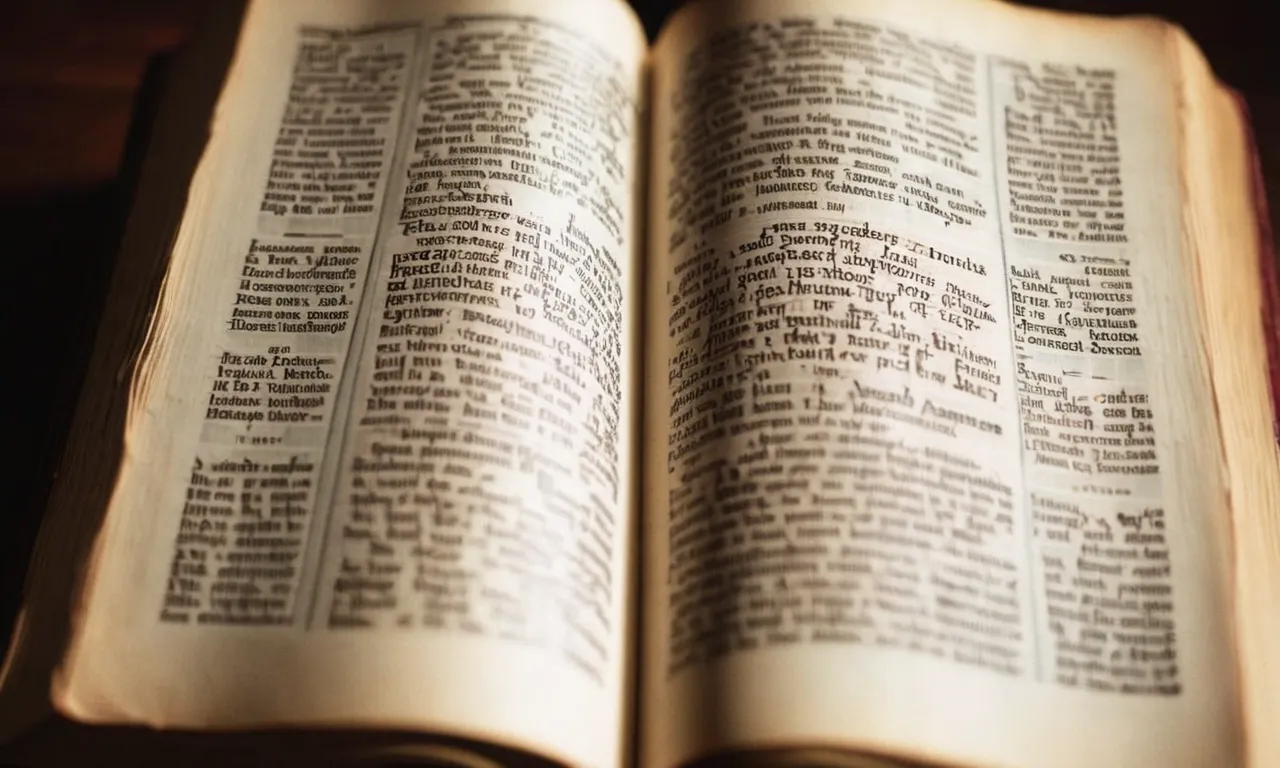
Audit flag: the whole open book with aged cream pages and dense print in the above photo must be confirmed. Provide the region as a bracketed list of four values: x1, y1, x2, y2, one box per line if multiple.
[0, 0, 1280, 768]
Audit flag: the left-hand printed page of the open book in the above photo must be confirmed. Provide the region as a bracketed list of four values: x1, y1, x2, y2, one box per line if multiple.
[28, 0, 645, 765]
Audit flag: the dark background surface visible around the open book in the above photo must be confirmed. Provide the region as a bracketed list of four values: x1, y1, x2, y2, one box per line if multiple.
[0, 0, 1280, 670]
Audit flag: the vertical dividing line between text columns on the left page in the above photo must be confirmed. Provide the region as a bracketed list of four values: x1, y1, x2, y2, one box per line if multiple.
[303, 26, 429, 631]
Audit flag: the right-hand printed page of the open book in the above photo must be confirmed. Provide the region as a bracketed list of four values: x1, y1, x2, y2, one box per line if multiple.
[643, 0, 1242, 768]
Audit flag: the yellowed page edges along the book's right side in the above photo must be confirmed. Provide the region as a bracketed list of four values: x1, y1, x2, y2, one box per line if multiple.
[1178, 36, 1280, 765]
